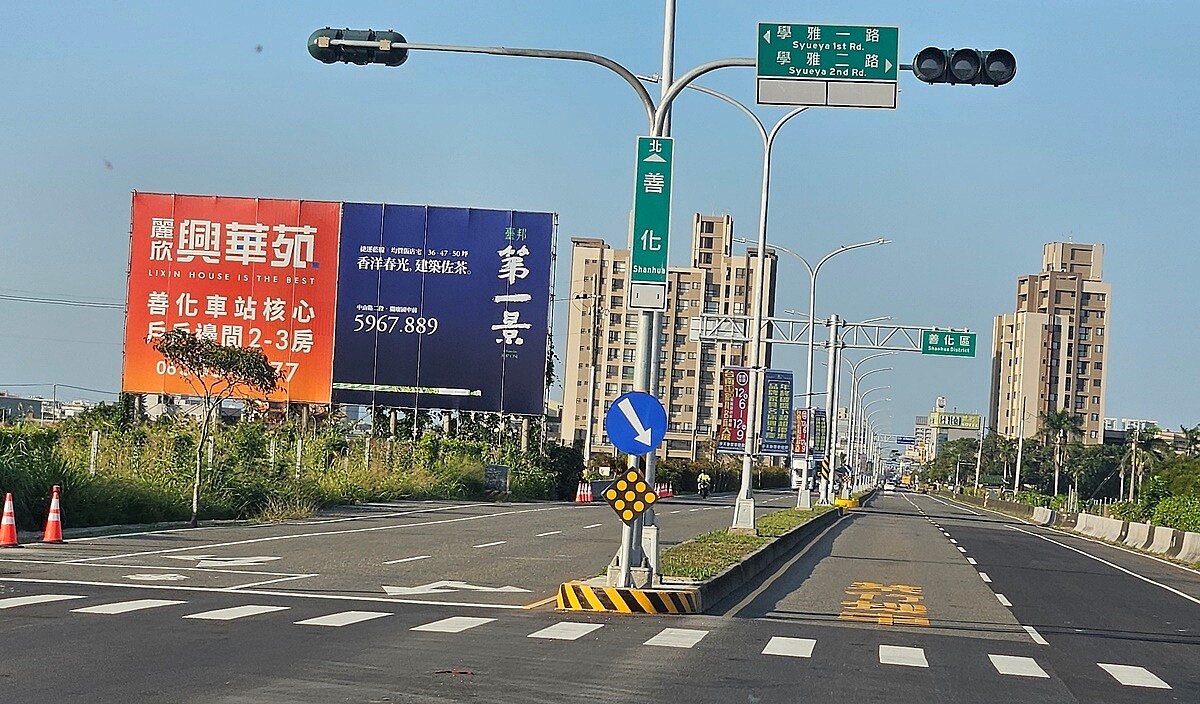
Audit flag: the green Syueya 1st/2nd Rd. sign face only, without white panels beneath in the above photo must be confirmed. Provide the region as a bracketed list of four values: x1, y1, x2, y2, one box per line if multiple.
[758, 22, 900, 80]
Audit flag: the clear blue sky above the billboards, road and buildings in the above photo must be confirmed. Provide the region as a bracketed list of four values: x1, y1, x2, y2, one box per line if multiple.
[0, 0, 1200, 433]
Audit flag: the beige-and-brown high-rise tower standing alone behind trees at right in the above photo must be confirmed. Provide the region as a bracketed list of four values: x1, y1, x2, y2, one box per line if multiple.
[989, 242, 1112, 444]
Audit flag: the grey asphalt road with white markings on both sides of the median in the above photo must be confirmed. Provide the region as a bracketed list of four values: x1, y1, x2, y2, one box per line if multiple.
[0, 494, 1200, 704]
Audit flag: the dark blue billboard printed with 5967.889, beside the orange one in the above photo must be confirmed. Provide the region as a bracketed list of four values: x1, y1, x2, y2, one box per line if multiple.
[332, 203, 554, 415]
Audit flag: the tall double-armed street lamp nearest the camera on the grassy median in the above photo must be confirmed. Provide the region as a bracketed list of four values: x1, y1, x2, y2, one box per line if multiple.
[638, 76, 808, 530]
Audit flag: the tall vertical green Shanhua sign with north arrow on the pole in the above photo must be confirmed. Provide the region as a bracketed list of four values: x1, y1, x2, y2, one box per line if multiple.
[628, 137, 674, 311]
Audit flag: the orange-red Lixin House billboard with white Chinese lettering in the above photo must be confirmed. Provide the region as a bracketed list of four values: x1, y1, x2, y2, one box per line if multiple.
[121, 193, 341, 403]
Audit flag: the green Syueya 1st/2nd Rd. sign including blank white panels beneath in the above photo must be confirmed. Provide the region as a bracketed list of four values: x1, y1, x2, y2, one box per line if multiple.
[757, 22, 900, 108]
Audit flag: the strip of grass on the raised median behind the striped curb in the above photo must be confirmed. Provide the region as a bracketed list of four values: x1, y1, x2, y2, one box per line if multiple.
[659, 506, 833, 580]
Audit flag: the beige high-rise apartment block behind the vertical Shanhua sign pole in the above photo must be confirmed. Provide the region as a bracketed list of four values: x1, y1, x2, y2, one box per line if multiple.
[560, 213, 778, 459]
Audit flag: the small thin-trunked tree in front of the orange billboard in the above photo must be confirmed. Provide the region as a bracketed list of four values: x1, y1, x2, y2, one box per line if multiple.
[150, 330, 278, 528]
